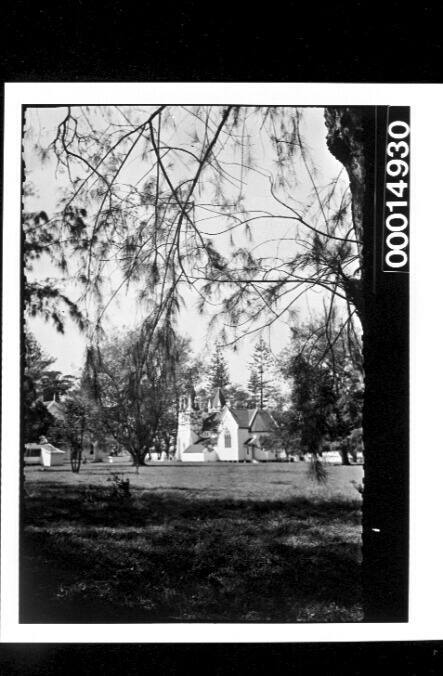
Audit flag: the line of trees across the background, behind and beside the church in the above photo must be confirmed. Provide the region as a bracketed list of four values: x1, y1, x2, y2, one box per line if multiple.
[23, 318, 363, 471]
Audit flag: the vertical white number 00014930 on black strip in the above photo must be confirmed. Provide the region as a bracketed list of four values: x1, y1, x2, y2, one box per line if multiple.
[383, 113, 410, 272]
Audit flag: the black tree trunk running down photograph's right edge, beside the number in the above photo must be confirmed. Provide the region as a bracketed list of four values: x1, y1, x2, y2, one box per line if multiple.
[325, 107, 409, 622]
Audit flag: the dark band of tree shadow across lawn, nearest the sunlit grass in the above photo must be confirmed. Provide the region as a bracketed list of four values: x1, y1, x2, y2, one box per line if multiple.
[23, 482, 361, 528]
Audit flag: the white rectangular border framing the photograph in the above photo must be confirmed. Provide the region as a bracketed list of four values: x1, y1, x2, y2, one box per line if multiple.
[0, 82, 443, 643]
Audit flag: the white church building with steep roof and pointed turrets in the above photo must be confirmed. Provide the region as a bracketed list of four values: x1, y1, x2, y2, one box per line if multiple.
[177, 388, 284, 462]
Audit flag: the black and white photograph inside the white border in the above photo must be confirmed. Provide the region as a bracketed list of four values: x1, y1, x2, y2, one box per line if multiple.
[3, 85, 442, 640]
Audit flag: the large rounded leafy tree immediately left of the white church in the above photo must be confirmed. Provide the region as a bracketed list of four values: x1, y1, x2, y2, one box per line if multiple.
[84, 320, 192, 471]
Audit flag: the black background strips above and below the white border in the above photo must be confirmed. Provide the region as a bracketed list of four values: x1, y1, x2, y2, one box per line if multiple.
[0, 0, 443, 675]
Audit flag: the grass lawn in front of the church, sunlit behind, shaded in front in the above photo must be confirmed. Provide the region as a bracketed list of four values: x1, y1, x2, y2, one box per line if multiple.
[20, 461, 363, 623]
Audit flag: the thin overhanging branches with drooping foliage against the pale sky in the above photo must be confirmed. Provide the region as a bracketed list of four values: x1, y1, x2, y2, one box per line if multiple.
[25, 106, 360, 342]
